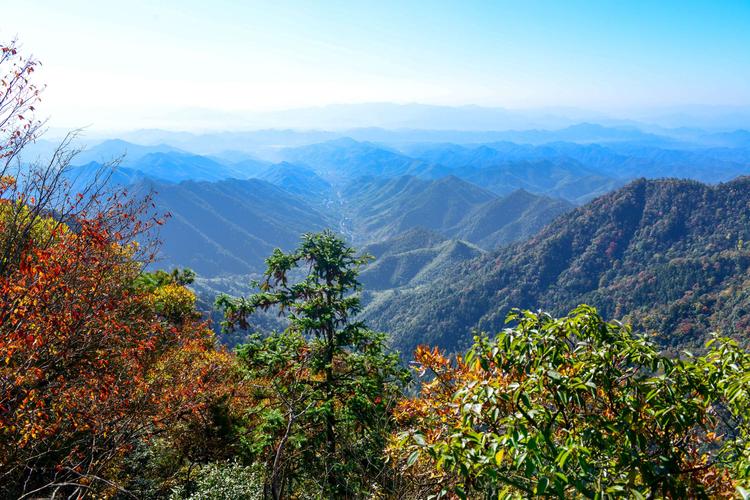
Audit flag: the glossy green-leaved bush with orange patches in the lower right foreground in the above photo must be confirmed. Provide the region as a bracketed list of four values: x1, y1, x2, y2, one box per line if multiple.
[390, 306, 750, 498]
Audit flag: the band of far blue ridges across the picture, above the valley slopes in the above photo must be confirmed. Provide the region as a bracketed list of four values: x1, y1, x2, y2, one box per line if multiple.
[63, 137, 750, 204]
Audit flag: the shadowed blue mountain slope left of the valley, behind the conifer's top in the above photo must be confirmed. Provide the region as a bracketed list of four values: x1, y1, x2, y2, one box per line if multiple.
[148, 179, 333, 277]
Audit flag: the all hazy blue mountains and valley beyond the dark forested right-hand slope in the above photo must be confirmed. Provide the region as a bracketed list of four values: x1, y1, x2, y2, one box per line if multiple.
[54, 132, 750, 286]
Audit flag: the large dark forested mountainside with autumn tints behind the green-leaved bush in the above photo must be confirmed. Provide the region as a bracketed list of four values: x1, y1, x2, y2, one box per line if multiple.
[364, 177, 750, 352]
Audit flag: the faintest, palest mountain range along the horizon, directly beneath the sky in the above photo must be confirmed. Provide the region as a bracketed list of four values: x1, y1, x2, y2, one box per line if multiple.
[104, 102, 750, 133]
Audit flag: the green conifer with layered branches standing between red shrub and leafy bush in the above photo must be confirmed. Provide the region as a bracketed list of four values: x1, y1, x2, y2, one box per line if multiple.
[217, 231, 407, 498]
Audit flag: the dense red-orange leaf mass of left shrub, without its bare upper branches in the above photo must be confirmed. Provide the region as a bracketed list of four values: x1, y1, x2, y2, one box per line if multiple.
[0, 214, 235, 491]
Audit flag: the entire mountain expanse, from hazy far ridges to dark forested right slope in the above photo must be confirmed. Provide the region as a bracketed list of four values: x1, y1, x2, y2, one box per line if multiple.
[36, 124, 750, 352]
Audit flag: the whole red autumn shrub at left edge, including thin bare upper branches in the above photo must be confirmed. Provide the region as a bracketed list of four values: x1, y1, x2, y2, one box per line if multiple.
[0, 41, 242, 498]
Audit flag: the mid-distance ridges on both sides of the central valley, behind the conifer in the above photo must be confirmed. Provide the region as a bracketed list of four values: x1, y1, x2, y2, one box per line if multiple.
[135, 168, 571, 280]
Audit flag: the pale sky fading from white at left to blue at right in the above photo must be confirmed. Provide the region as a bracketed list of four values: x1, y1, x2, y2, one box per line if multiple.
[0, 0, 750, 128]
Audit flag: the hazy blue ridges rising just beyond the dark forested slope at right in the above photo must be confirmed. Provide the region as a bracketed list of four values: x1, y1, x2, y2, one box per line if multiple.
[405, 142, 749, 203]
